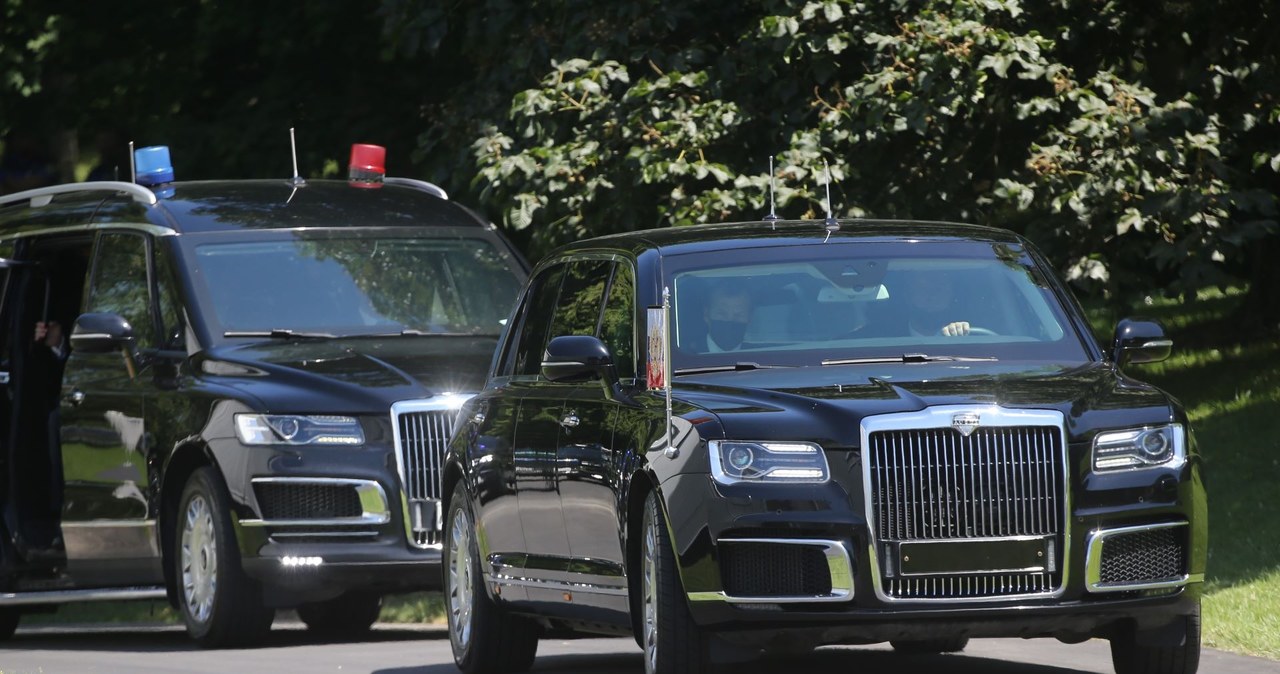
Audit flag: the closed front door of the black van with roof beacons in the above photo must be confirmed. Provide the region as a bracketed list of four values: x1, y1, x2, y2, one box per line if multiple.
[59, 231, 160, 583]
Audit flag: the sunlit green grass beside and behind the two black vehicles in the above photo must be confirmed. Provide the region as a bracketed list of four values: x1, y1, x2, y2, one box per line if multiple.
[24, 292, 1280, 659]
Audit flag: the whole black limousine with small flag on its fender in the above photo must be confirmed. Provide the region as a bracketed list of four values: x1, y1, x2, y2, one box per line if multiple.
[444, 221, 1207, 674]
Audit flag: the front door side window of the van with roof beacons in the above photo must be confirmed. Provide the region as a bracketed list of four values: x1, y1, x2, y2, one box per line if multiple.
[87, 233, 155, 348]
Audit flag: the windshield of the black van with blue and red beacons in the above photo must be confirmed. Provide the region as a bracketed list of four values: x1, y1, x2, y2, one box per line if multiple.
[196, 234, 521, 336]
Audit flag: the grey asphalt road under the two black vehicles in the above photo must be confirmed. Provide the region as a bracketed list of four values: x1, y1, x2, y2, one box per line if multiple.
[0, 623, 1280, 674]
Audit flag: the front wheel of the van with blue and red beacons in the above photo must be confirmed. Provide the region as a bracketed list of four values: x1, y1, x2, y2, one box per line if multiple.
[173, 467, 275, 648]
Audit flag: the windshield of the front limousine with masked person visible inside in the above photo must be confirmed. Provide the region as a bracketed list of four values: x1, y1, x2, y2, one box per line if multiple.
[666, 240, 1088, 373]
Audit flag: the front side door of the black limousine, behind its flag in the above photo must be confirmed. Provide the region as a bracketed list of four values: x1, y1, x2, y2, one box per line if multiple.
[557, 260, 636, 611]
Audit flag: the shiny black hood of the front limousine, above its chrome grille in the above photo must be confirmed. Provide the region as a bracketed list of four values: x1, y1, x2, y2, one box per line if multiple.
[673, 362, 1183, 448]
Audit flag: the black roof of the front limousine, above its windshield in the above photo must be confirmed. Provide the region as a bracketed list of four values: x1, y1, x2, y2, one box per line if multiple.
[552, 219, 1025, 257]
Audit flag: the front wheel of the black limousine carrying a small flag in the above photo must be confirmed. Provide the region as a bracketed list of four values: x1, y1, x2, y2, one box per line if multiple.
[640, 491, 708, 674]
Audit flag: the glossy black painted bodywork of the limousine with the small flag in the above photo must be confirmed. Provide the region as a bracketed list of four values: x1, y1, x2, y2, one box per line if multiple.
[449, 223, 1207, 646]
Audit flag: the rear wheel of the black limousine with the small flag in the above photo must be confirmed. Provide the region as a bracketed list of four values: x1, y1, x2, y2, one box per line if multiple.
[443, 486, 538, 674]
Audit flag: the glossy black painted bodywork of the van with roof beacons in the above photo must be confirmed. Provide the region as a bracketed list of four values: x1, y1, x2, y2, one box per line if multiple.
[0, 180, 527, 606]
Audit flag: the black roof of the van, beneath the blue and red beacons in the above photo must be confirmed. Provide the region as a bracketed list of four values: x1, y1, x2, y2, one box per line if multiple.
[0, 179, 493, 234]
